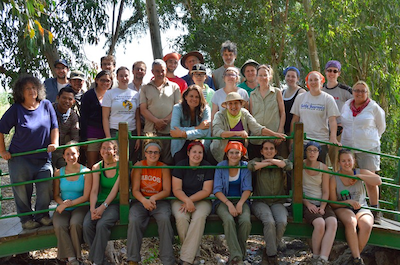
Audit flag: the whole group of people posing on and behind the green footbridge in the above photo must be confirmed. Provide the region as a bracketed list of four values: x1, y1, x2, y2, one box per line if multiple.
[0, 41, 385, 264]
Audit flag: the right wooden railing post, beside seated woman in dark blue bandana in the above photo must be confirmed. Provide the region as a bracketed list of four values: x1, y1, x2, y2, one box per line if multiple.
[292, 123, 304, 223]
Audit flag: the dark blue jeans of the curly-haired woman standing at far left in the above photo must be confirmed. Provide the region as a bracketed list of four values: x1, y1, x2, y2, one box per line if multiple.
[8, 156, 53, 223]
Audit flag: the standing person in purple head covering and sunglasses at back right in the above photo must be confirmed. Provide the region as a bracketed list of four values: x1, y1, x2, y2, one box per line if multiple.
[322, 60, 353, 168]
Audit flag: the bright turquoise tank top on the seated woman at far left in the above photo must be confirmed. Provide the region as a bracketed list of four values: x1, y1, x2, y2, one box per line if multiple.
[60, 165, 86, 211]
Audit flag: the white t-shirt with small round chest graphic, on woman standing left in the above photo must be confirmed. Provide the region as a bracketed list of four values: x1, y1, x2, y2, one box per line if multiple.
[101, 88, 139, 131]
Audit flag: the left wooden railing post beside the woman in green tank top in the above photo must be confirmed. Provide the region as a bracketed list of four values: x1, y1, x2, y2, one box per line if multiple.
[118, 122, 129, 224]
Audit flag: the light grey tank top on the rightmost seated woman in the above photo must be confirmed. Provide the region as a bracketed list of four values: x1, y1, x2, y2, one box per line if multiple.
[335, 168, 368, 206]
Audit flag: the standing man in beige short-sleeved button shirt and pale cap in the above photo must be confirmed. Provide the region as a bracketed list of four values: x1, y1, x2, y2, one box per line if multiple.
[140, 59, 181, 165]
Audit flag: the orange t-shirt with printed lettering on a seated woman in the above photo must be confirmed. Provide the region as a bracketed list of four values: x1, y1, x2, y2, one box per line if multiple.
[140, 160, 165, 196]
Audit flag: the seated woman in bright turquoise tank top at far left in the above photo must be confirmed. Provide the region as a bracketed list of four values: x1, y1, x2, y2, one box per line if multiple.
[53, 141, 92, 265]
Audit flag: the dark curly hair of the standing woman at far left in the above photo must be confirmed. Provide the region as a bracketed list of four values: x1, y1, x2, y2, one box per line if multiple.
[12, 75, 46, 103]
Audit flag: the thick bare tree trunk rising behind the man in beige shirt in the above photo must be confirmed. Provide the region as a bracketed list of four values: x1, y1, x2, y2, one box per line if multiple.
[146, 0, 163, 59]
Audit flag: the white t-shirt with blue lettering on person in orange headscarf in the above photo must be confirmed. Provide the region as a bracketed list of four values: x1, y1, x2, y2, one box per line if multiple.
[290, 92, 340, 142]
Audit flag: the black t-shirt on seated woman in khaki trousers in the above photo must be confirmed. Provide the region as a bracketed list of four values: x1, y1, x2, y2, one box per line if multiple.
[172, 158, 214, 197]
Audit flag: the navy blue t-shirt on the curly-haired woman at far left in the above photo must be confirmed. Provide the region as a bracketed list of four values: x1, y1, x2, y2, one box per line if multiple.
[0, 99, 58, 159]
